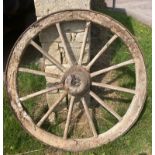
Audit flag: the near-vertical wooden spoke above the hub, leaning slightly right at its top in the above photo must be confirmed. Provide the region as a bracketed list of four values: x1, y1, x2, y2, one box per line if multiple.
[78, 22, 91, 65]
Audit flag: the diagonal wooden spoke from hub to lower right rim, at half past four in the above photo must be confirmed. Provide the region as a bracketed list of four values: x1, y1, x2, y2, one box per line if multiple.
[90, 91, 122, 121]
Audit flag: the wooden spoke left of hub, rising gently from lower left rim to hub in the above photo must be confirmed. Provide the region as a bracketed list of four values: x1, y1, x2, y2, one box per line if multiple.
[19, 84, 63, 101]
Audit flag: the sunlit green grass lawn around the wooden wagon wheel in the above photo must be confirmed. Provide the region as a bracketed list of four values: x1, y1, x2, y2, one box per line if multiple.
[4, 10, 152, 155]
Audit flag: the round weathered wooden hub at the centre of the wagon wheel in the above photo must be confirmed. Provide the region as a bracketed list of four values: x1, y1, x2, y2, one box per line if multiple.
[63, 66, 90, 96]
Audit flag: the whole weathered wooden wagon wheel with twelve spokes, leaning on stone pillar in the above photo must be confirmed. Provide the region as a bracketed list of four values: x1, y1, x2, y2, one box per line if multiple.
[6, 10, 147, 151]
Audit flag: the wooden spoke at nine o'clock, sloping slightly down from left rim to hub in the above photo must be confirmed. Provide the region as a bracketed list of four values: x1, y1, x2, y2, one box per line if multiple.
[18, 67, 61, 79]
